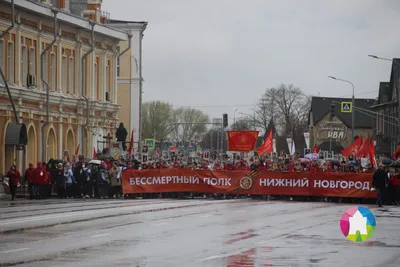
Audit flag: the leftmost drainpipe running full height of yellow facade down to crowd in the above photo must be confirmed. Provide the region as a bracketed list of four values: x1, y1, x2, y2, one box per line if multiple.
[40, 9, 58, 162]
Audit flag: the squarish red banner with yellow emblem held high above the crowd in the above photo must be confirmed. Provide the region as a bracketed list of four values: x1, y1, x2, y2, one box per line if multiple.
[227, 131, 258, 152]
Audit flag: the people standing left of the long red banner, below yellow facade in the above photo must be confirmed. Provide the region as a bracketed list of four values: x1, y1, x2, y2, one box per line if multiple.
[6, 158, 126, 200]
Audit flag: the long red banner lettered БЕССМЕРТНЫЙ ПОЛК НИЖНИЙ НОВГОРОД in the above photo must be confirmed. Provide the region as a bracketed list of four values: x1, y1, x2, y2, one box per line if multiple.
[122, 169, 376, 198]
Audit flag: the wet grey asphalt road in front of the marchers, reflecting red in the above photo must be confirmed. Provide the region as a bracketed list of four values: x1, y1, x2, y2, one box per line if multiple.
[0, 199, 400, 267]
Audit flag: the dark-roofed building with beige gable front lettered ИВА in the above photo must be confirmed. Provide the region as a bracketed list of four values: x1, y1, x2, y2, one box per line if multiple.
[308, 97, 375, 153]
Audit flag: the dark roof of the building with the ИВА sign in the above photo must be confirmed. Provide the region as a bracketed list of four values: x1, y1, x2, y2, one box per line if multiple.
[309, 96, 375, 128]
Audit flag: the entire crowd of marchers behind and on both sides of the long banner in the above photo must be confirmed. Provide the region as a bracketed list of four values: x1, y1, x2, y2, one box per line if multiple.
[2, 154, 400, 205]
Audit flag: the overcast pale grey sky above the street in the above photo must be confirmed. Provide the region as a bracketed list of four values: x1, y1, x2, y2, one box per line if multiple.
[103, 0, 400, 125]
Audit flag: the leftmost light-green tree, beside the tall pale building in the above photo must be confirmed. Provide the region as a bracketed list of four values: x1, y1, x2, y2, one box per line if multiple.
[142, 101, 174, 140]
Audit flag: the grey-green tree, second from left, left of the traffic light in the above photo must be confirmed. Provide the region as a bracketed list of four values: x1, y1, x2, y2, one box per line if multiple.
[172, 108, 210, 142]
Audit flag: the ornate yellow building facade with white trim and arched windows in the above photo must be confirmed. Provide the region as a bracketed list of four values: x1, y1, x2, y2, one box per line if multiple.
[0, 1, 128, 174]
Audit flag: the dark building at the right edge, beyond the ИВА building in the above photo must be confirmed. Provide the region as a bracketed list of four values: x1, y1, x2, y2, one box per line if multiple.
[371, 58, 400, 156]
